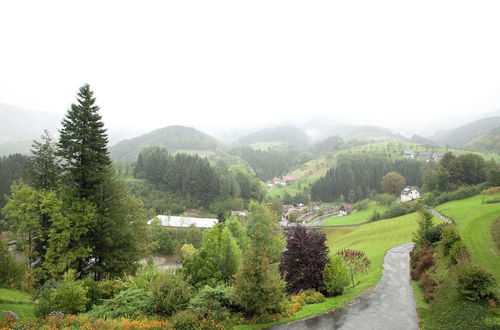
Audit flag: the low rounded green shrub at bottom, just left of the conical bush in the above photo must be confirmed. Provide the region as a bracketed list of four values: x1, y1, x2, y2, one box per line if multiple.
[189, 284, 237, 320]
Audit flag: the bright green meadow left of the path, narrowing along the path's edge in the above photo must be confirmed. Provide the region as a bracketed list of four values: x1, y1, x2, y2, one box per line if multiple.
[235, 213, 438, 329]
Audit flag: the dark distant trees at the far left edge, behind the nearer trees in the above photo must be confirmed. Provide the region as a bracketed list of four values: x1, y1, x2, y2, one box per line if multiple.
[0, 154, 28, 209]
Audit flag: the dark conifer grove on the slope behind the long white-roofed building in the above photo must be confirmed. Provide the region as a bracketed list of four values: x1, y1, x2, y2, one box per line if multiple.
[134, 147, 263, 207]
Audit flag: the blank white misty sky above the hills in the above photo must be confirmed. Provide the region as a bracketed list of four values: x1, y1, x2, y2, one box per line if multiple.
[0, 0, 500, 135]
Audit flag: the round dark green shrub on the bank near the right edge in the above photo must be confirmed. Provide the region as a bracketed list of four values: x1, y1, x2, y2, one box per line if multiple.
[457, 264, 496, 301]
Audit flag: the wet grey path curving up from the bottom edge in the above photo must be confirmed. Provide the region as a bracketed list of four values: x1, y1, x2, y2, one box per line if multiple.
[271, 243, 419, 330]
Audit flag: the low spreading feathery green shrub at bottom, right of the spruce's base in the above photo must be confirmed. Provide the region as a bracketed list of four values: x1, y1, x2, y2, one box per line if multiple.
[89, 288, 153, 319]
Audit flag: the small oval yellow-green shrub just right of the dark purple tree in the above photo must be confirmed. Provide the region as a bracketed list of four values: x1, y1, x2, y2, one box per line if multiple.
[323, 254, 350, 296]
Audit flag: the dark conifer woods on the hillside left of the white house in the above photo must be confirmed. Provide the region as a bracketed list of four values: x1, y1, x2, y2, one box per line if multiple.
[311, 153, 433, 202]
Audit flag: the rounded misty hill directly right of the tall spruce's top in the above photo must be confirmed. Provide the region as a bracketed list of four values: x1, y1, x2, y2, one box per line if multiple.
[109, 125, 222, 160]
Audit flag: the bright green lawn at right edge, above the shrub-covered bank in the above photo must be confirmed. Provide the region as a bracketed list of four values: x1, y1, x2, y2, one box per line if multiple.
[436, 194, 500, 284]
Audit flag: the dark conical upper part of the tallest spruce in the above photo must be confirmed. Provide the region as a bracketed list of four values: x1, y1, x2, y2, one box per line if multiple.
[58, 84, 111, 201]
